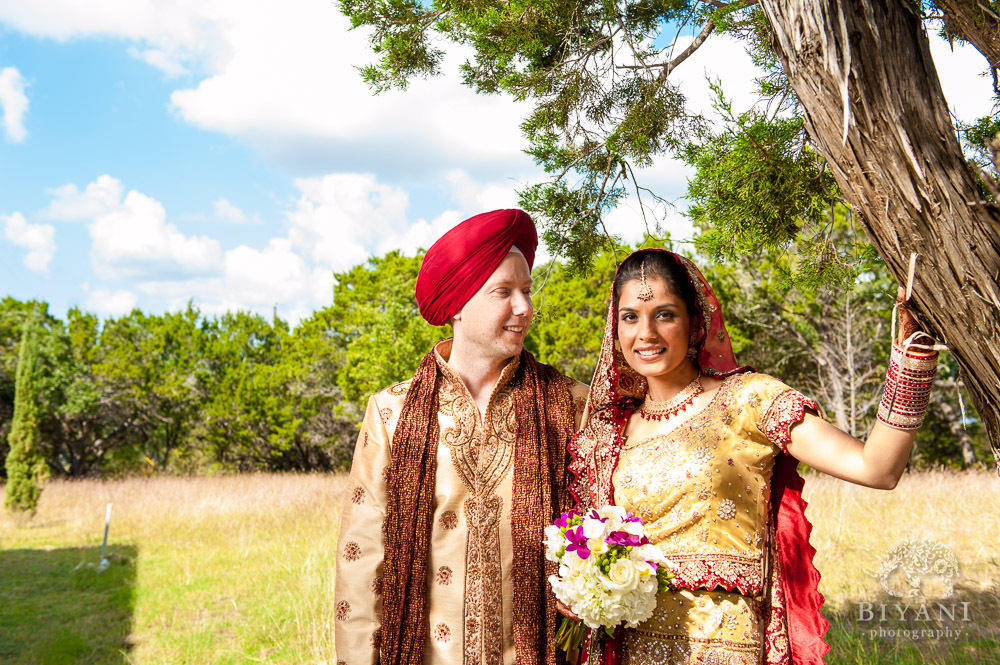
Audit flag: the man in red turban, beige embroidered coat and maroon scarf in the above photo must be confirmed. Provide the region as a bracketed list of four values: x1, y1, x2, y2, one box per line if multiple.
[335, 210, 587, 665]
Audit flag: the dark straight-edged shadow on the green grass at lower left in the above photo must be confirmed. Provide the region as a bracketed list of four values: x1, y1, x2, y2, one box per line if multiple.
[0, 545, 137, 665]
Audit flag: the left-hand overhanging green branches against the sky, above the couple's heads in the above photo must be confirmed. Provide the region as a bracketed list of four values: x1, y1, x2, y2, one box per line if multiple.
[341, 0, 708, 269]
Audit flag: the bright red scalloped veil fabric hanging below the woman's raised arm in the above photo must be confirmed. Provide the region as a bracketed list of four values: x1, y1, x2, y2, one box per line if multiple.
[773, 455, 830, 665]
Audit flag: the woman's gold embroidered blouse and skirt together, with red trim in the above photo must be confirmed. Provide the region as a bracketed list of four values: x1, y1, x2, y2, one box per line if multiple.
[613, 373, 818, 663]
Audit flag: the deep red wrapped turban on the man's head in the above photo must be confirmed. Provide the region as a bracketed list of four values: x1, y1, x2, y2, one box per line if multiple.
[417, 209, 538, 326]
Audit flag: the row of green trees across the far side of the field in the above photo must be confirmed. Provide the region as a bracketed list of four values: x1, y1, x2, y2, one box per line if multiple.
[0, 239, 987, 476]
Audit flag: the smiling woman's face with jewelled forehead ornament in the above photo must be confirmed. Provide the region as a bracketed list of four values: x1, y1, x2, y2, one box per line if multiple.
[618, 276, 693, 379]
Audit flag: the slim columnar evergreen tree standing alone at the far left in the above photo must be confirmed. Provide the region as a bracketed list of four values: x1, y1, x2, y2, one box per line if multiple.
[4, 317, 45, 515]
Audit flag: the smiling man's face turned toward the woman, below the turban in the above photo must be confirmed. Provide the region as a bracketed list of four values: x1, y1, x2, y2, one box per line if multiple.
[453, 252, 532, 360]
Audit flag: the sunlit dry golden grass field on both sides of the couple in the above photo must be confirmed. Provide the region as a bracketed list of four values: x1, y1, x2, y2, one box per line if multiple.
[0, 472, 1000, 665]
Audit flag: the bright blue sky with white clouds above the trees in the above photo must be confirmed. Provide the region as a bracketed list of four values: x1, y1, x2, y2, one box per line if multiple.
[0, 0, 989, 320]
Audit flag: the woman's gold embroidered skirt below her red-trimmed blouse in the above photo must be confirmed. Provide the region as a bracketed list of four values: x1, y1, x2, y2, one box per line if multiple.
[622, 589, 765, 665]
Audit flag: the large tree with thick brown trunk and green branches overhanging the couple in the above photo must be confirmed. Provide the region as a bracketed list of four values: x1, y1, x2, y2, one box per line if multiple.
[341, 0, 1000, 462]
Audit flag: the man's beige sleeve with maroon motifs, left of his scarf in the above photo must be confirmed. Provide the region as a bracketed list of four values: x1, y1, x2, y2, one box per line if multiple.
[334, 397, 389, 665]
